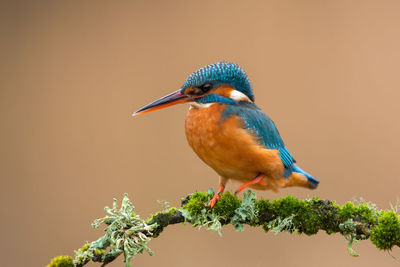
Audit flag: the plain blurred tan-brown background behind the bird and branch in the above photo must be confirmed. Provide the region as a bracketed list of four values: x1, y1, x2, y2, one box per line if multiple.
[0, 0, 400, 267]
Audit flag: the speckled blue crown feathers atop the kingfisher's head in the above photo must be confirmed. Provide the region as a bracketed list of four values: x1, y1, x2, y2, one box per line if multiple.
[182, 62, 254, 101]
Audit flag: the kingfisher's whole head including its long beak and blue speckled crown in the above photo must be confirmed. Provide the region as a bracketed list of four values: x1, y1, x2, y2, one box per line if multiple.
[133, 62, 254, 116]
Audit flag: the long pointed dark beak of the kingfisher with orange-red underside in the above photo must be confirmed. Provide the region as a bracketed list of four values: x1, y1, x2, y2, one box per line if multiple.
[132, 90, 194, 116]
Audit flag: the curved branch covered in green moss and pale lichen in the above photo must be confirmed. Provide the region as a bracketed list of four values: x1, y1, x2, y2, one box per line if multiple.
[48, 191, 400, 267]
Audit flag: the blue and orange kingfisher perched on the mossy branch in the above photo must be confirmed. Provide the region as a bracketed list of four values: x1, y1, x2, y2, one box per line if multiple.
[133, 62, 319, 208]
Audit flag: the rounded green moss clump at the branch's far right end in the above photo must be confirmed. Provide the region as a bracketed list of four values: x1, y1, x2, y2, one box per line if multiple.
[371, 211, 400, 250]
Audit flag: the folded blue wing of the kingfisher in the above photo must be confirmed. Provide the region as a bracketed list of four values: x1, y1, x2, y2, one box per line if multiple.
[223, 102, 296, 178]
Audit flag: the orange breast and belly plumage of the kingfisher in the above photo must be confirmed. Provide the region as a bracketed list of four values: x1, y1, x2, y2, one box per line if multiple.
[185, 103, 283, 185]
